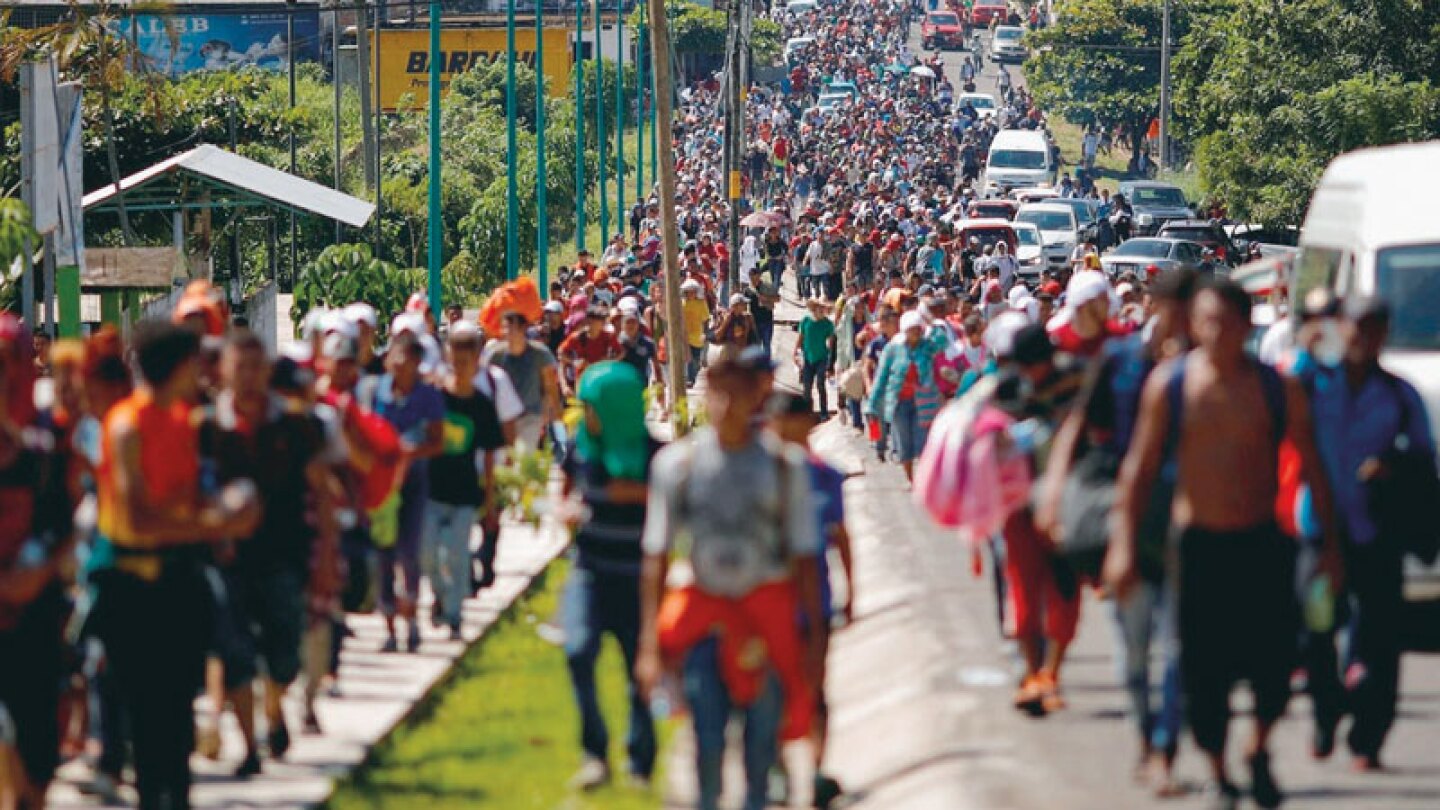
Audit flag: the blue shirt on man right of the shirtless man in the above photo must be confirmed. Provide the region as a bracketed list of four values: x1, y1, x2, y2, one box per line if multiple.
[1310, 366, 1434, 545]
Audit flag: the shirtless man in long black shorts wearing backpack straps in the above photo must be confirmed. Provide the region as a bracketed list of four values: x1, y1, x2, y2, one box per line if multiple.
[1104, 281, 1339, 810]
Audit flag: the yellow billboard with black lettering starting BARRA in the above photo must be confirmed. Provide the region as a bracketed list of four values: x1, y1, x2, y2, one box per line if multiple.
[372, 27, 572, 112]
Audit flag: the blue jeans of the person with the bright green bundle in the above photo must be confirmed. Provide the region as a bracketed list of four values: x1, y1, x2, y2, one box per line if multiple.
[560, 565, 655, 778]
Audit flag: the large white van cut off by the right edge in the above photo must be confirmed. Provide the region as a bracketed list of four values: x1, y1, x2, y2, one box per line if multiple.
[1290, 141, 1440, 601]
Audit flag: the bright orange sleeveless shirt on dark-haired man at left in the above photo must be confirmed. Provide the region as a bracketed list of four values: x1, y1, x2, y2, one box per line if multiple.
[95, 391, 200, 549]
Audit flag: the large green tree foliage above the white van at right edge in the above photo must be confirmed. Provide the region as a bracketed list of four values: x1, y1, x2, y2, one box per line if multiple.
[1175, 0, 1440, 225]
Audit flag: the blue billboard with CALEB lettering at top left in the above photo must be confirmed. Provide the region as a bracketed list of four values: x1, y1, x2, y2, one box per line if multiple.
[117, 9, 320, 76]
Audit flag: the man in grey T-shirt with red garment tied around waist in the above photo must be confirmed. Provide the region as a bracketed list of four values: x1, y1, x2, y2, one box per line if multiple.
[635, 362, 824, 810]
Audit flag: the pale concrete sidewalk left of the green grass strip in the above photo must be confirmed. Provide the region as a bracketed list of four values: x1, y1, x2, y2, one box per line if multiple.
[50, 513, 567, 810]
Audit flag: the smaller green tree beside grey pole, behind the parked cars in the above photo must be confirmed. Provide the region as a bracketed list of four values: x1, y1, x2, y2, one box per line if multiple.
[1025, 0, 1187, 168]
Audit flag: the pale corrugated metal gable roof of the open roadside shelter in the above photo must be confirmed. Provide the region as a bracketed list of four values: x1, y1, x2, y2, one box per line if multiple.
[85, 144, 374, 228]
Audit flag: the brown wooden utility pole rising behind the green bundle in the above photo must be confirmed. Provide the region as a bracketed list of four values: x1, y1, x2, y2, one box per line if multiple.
[647, 0, 690, 429]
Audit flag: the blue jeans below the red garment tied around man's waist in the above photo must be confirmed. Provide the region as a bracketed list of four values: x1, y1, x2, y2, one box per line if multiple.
[684, 638, 782, 810]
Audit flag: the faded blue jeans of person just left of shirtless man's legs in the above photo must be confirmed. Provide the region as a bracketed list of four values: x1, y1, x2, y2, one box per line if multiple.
[1110, 579, 1182, 755]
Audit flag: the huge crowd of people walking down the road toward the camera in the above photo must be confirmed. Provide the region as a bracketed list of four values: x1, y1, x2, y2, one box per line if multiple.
[0, 0, 1434, 810]
